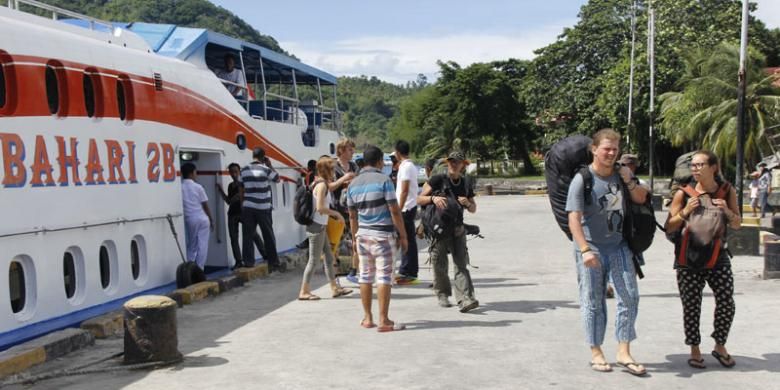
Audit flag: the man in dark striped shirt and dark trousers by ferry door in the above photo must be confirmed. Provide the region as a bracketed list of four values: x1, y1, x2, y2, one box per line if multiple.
[238, 147, 286, 272]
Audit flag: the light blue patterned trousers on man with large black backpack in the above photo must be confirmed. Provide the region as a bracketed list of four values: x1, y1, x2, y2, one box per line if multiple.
[574, 243, 639, 346]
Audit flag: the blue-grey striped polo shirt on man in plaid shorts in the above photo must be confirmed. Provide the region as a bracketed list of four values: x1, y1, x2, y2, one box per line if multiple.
[347, 167, 398, 237]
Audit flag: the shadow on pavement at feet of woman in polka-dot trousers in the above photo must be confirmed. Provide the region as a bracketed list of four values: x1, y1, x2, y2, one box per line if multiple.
[645, 350, 780, 378]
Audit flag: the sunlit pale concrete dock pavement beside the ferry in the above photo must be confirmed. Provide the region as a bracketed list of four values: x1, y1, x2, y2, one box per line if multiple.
[7, 196, 780, 389]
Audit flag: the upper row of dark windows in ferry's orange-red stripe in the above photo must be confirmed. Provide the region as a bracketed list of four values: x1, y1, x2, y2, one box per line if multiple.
[0, 52, 134, 121]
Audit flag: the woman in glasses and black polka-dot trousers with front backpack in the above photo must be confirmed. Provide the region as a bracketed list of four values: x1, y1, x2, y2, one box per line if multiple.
[666, 150, 742, 369]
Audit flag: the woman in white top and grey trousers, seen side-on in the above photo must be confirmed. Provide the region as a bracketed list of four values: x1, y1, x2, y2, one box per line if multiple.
[298, 156, 352, 301]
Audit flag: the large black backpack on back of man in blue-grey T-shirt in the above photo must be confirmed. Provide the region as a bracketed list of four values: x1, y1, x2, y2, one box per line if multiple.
[544, 135, 593, 240]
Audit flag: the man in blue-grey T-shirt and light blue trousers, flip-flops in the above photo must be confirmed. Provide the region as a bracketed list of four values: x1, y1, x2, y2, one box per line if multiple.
[566, 129, 647, 375]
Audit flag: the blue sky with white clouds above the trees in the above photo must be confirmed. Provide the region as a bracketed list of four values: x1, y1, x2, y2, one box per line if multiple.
[211, 0, 780, 84]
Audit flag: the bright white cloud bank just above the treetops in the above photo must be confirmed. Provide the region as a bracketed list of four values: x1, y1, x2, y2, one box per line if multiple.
[281, 22, 573, 84]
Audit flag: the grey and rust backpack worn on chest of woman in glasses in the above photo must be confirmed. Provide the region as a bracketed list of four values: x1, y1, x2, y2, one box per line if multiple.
[674, 182, 731, 269]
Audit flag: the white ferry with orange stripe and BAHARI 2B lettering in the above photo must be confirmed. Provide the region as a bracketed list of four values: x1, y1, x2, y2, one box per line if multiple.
[0, 0, 340, 349]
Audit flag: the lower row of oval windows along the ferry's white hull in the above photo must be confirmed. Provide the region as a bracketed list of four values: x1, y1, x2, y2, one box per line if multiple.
[8, 236, 147, 315]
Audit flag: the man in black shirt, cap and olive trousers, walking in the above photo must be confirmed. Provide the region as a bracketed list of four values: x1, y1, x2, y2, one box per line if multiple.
[417, 151, 479, 313]
